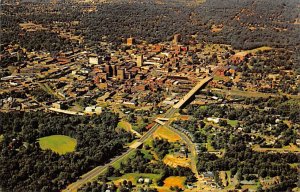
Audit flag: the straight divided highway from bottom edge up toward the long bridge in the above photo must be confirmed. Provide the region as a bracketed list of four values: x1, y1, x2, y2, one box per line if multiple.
[62, 108, 176, 192]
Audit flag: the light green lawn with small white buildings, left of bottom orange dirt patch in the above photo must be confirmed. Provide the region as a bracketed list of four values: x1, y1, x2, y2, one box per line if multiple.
[113, 173, 161, 186]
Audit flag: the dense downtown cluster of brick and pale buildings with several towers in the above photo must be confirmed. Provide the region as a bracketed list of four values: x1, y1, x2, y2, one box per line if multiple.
[1, 35, 216, 110]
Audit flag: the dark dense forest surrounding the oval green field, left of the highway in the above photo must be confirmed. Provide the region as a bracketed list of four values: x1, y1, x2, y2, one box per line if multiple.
[0, 112, 133, 191]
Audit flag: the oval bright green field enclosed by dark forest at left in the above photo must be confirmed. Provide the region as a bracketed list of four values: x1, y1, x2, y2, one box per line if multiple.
[39, 135, 77, 155]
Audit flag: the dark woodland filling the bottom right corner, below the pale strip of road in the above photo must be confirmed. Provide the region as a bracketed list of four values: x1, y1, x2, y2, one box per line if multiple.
[197, 145, 298, 191]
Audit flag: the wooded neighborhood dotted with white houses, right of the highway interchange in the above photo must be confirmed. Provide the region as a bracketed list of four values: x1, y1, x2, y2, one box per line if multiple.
[172, 97, 300, 148]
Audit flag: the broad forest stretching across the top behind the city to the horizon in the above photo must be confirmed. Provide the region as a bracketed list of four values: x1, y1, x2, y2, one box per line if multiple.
[1, 0, 299, 51]
